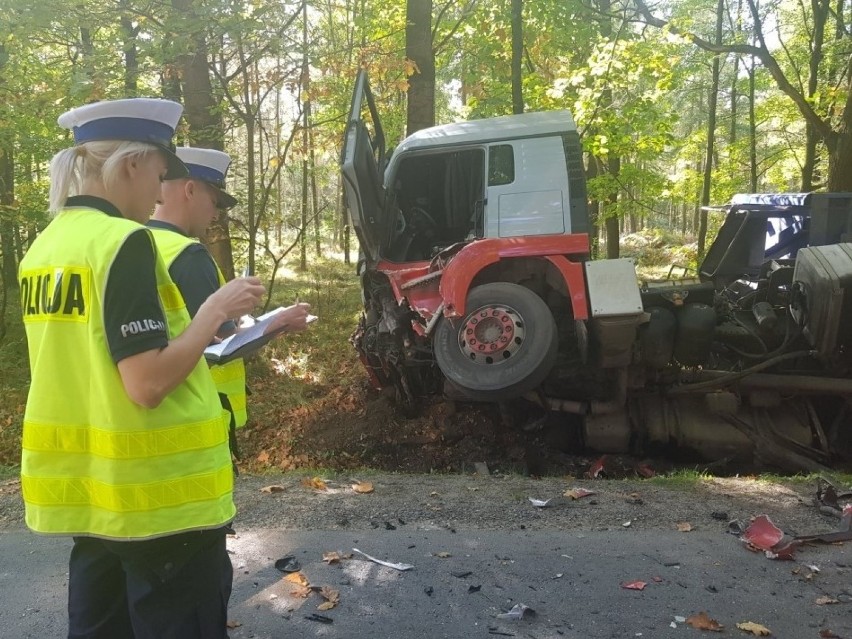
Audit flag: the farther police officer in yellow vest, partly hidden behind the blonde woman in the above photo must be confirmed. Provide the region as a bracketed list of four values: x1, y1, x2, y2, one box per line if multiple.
[148, 147, 309, 444]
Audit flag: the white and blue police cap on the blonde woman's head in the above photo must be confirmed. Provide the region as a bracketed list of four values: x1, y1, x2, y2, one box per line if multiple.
[57, 98, 187, 179]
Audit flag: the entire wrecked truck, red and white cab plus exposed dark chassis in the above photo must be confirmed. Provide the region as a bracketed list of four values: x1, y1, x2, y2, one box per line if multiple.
[342, 72, 852, 470]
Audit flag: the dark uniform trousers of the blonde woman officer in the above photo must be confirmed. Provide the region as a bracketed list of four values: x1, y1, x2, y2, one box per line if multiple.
[68, 528, 233, 639]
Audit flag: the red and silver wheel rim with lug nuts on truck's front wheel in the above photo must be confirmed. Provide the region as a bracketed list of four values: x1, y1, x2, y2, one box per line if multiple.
[459, 306, 525, 366]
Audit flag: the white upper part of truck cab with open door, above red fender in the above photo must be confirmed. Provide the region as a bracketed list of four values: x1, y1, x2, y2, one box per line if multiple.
[342, 71, 588, 263]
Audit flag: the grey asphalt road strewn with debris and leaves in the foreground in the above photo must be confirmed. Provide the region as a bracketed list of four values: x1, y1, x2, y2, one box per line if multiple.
[0, 522, 852, 639]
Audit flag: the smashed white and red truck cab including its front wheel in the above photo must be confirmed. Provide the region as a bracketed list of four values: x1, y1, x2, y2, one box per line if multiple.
[342, 71, 620, 406]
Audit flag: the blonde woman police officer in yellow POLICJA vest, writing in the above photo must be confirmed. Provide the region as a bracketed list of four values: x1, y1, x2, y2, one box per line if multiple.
[19, 98, 264, 639]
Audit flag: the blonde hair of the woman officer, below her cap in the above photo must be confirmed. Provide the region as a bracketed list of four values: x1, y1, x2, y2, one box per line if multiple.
[49, 140, 157, 214]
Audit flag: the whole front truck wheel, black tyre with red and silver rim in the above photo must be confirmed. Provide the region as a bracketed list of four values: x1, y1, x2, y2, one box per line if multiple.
[434, 282, 558, 400]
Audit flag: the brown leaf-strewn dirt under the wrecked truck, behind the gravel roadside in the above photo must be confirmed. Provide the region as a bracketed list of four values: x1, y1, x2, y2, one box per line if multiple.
[239, 383, 745, 479]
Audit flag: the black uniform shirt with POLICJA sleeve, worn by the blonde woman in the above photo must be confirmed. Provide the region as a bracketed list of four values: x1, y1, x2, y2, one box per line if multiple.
[65, 195, 169, 363]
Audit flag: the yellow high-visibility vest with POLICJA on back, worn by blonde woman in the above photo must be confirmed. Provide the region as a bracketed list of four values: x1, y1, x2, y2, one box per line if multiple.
[19, 207, 236, 540]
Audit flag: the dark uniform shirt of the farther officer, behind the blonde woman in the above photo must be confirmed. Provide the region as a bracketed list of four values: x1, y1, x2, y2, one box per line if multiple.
[148, 220, 237, 336]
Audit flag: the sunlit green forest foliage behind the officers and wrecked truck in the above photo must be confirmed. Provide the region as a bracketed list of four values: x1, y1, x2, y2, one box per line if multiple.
[0, 0, 852, 298]
